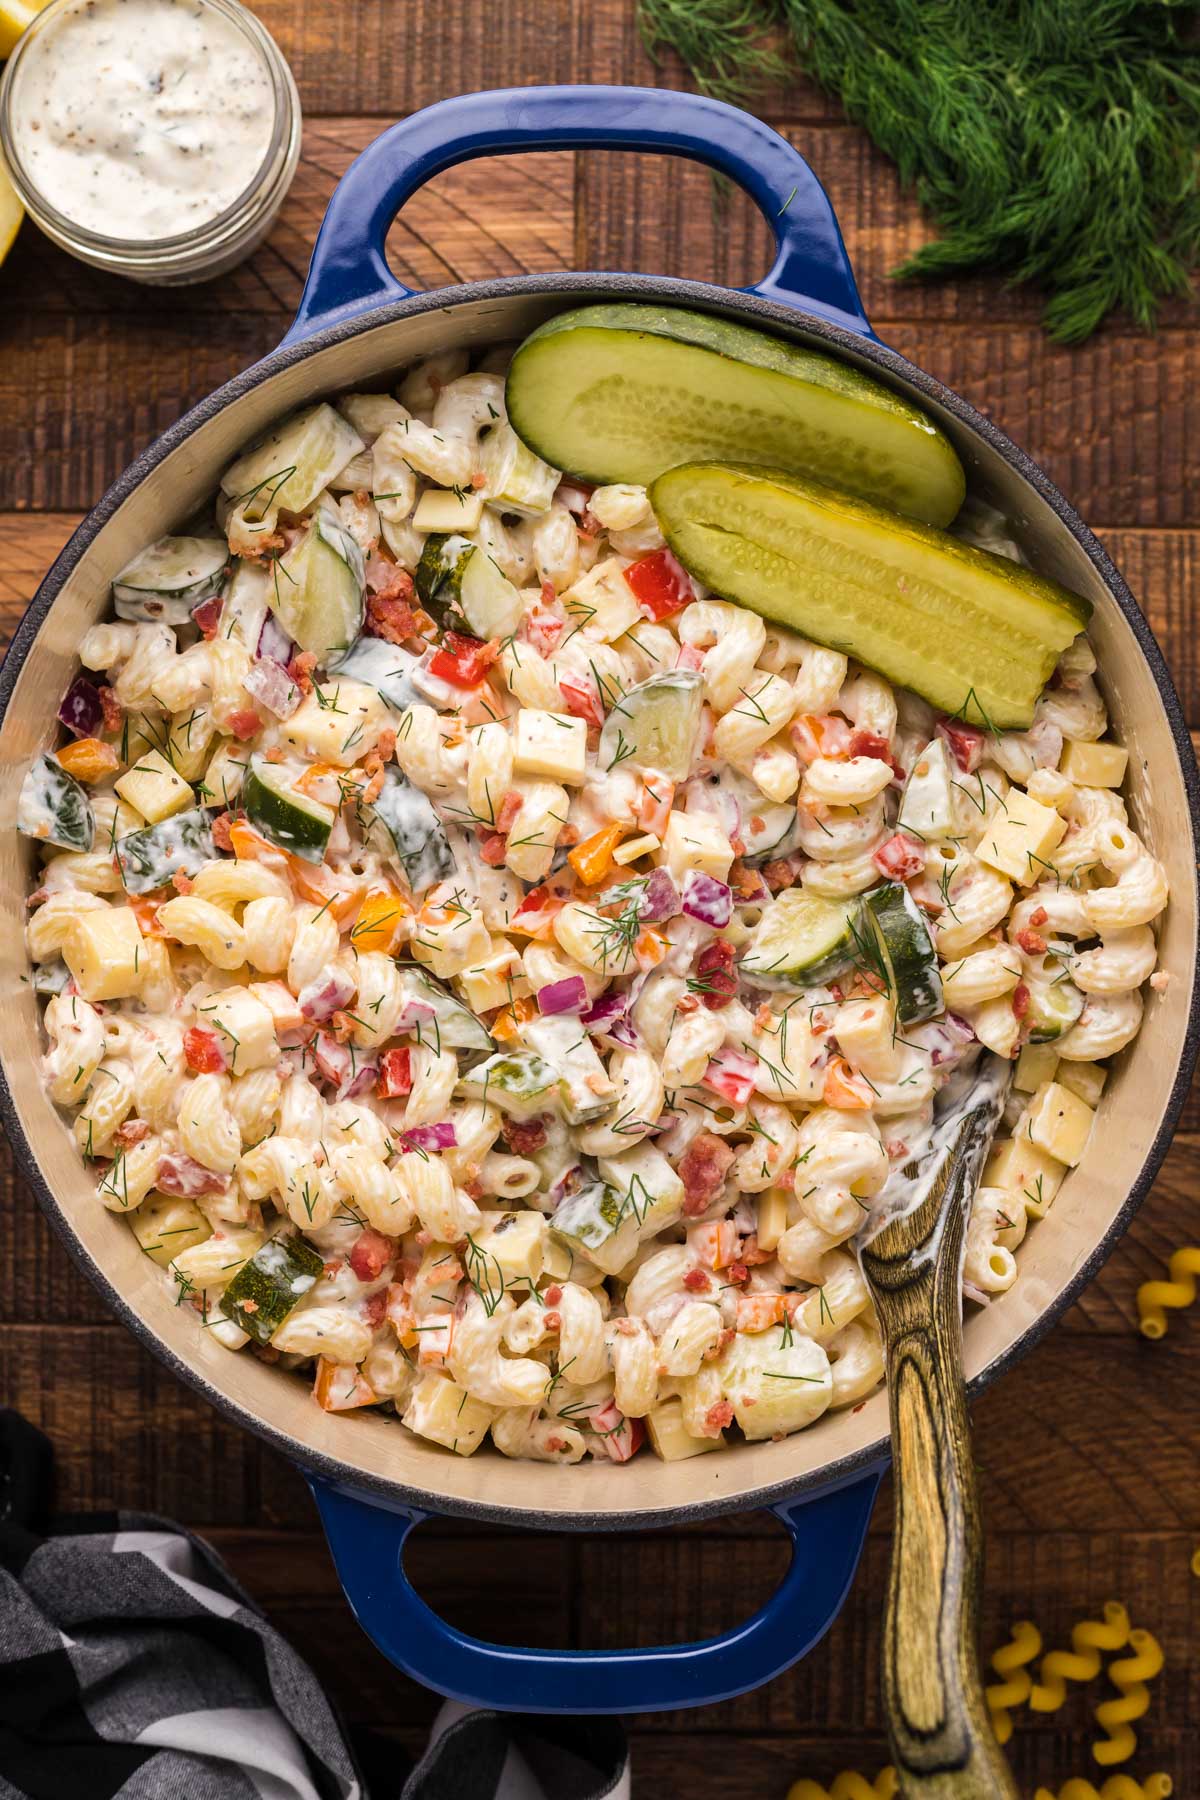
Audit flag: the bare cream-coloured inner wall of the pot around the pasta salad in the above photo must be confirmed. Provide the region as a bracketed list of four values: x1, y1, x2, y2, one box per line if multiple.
[0, 284, 1196, 1517]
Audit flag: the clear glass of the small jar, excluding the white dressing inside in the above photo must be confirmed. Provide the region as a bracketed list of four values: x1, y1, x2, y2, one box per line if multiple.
[0, 0, 300, 286]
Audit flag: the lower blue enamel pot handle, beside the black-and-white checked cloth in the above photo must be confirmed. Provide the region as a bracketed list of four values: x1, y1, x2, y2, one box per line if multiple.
[308, 1467, 883, 1714]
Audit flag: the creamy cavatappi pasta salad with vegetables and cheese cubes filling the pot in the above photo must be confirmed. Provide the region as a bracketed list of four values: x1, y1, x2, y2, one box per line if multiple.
[20, 353, 1168, 1462]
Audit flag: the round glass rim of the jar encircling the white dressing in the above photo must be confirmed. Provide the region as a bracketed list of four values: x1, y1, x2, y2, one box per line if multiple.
[0, 0, 299, 265]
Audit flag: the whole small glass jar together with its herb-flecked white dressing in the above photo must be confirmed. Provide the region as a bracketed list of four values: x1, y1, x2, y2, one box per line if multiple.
[0, 0, 300, 284]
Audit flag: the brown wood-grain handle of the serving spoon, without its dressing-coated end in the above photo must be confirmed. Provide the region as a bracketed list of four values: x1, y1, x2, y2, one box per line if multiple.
[864, 1204, 1018, 1800]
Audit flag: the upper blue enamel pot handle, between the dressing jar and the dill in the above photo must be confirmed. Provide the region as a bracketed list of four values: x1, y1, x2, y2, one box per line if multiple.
[282, 86, 873, 344]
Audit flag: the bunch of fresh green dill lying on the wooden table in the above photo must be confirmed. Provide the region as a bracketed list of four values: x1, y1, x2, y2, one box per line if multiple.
[639, 0, 1200, 344]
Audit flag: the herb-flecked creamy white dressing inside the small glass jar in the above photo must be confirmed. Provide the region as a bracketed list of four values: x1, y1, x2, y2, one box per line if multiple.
[11, 0, 275, 243]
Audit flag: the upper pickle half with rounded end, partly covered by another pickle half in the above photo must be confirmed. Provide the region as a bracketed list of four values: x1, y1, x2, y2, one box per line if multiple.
[506, 306, 966, 526]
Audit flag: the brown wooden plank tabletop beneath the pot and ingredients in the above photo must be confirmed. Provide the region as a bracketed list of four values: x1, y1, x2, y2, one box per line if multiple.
[0, 0, 1200, 1800]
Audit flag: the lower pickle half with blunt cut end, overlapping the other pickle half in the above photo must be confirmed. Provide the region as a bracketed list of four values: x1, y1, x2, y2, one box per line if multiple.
[651, 463, 1092, 729]
